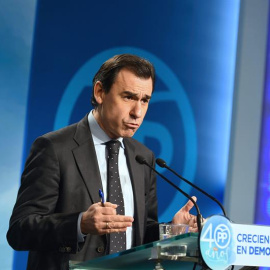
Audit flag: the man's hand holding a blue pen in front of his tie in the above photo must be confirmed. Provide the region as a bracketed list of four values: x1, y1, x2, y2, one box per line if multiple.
[81, 202, 134, 235]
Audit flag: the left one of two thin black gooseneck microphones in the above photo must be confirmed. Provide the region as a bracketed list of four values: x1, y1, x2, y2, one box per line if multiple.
[135, 155, 202, 233]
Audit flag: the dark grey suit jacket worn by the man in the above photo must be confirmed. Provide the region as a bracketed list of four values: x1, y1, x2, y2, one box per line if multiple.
[7, 116, 158, 270]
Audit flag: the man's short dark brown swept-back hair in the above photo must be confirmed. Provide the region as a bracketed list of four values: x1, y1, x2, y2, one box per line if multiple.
[91, 54, 155, 108]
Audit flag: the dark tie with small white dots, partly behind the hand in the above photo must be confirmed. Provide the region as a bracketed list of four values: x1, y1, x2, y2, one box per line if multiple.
[106, 141, 126, 254]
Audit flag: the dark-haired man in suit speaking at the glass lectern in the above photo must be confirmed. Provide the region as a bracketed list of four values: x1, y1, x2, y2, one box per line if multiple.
[7, 54, 196, 270]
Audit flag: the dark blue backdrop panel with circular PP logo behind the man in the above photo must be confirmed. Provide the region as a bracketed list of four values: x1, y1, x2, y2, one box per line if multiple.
[14, 0, 239, 269]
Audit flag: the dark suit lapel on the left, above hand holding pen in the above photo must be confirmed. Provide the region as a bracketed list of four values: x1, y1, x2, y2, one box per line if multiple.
[73, 116, 102, 203]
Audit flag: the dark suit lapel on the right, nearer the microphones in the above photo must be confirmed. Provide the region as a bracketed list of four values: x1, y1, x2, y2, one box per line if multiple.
[124, 139, 145, 245]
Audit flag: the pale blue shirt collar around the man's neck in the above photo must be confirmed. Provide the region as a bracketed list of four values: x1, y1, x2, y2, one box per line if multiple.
[88, 110, 125, 148]
